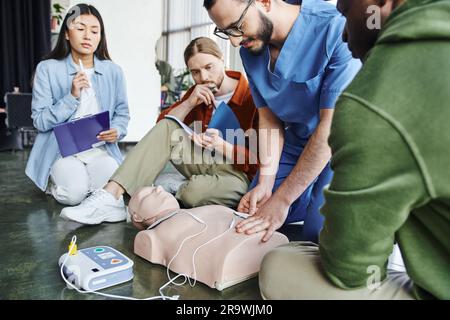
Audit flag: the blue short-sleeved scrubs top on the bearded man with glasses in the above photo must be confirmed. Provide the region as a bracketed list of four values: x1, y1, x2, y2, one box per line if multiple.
[240, 0, 361, 150]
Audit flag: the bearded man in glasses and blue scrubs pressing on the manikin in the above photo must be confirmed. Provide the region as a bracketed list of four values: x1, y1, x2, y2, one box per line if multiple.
[204, 0, 361, 242]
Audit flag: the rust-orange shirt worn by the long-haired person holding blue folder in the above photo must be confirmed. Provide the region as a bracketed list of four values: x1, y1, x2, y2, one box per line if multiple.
[158, 71, 258, 181]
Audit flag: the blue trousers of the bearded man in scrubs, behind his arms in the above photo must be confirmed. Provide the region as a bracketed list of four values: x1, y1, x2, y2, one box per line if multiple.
[250, 144, 333, 243]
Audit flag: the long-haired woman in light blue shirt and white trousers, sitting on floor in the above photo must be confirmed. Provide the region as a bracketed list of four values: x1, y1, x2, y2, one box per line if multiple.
[26, 4, 129, 205]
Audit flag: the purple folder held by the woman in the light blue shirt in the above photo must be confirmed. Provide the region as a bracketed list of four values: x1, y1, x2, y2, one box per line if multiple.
[53, 111, 110, 158]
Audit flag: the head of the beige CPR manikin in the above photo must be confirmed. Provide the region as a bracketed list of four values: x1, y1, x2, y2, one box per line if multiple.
[128, 186, 180, 230]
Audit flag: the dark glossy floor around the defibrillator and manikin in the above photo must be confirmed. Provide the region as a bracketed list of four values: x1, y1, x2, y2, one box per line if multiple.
[0, 151, 260, 300]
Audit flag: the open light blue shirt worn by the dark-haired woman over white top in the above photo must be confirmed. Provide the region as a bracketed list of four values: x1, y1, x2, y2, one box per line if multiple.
[25, 54, 130, 191]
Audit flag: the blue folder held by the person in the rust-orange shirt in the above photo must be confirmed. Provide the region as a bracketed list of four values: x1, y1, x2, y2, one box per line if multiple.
[208, 102, 242, 145]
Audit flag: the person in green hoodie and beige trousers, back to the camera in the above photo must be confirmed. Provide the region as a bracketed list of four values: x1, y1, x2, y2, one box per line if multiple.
[259, 0, 450, 299]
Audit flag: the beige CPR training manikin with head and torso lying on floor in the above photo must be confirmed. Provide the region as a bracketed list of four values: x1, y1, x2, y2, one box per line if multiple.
[128, 187, 288, 290]
